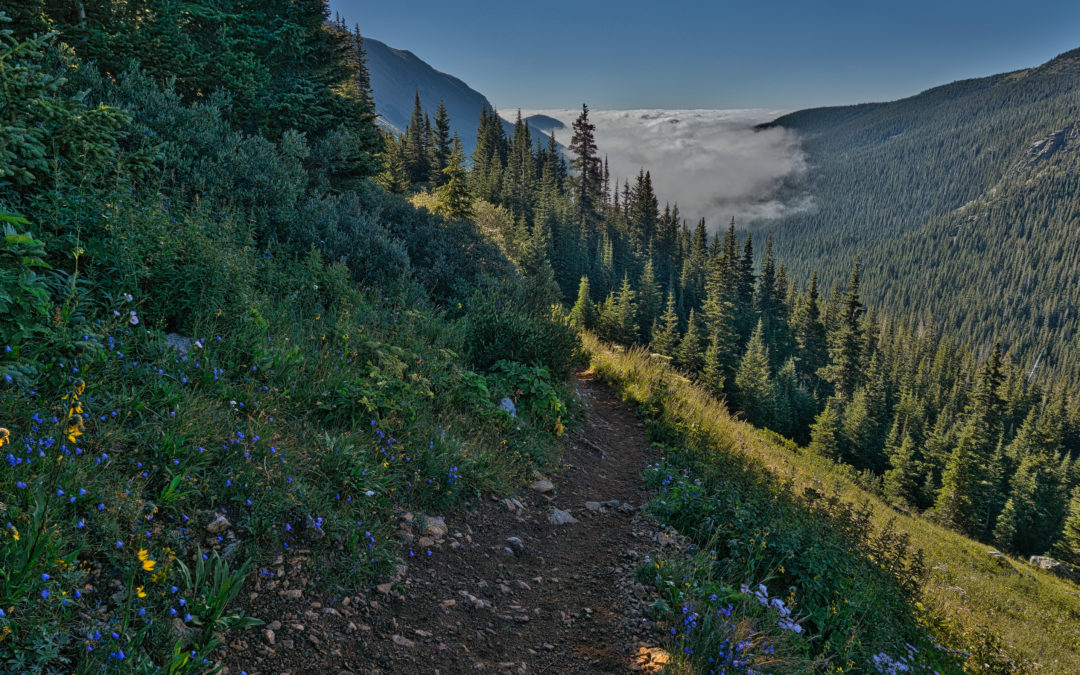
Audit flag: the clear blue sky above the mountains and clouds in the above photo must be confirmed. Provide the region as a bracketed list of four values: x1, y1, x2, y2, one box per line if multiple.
[330, 0, 1080, 109]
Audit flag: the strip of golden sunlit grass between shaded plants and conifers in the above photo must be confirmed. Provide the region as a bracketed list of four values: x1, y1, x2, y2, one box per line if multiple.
[585, 338, 1080, 673]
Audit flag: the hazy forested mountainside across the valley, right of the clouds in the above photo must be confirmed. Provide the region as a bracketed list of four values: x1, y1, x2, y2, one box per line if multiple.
[755, 51, 1080, 379]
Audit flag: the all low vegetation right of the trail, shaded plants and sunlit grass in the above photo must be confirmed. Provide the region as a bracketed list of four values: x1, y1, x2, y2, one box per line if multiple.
[586, 338, 1080, 673]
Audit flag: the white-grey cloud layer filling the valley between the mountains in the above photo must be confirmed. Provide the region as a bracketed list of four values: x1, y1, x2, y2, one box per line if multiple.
[514, 109, 810, 229]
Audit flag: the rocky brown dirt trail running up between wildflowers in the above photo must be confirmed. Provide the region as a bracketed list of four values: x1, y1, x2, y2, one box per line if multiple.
[226, 374, 664, 675]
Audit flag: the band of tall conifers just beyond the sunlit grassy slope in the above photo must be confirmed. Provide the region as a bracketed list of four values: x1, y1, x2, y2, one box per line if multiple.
[390, 98, 1080, 561]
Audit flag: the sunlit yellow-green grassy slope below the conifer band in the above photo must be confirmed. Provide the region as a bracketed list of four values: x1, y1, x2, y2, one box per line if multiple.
[586, 340, 1080, 673]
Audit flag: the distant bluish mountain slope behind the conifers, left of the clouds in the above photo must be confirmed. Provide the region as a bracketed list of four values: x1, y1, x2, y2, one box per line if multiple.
[364, 38, 550, 156]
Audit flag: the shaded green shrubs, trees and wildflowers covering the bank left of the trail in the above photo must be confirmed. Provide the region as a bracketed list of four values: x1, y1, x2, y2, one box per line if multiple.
[0, 6, 578, 673]
